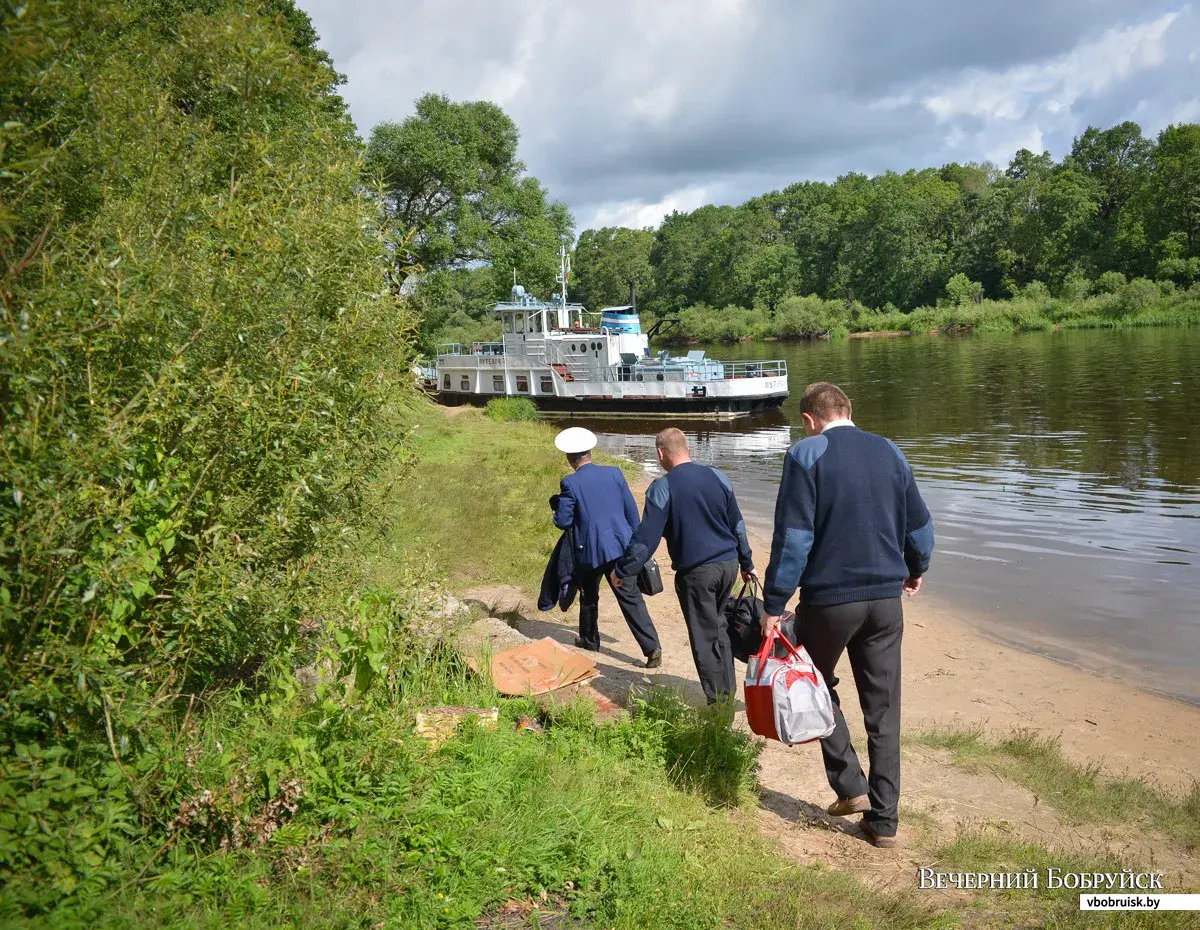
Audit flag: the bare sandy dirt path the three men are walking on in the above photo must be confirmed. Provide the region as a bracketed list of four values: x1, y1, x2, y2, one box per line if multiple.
[467, 506, 1200, 888]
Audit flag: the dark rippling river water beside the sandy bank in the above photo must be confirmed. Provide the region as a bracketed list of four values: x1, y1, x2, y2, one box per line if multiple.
[564, 329, 1200, 703]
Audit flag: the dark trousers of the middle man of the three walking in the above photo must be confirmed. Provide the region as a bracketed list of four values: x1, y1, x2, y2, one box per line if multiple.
[676, 559, 738, 704]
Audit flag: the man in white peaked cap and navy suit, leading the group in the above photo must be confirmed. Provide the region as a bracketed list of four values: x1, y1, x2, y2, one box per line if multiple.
[551, 426, 662, 668]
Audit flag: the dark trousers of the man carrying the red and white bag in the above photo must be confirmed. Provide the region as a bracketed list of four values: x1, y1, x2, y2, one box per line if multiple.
[796, 598, 904, 836]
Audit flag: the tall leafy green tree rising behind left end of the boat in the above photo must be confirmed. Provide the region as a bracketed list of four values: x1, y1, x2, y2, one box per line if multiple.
[367, 94, 572, 288]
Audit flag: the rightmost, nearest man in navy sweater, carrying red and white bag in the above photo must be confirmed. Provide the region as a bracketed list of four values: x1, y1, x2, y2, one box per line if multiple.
[762, 382, 934, 847]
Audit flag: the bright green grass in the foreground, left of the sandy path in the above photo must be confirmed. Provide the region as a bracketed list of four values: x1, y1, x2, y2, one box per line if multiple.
[67, 653, 954, 930]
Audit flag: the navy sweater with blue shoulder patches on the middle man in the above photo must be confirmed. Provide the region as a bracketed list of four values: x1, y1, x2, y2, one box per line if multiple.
[617, 462, 754, 578]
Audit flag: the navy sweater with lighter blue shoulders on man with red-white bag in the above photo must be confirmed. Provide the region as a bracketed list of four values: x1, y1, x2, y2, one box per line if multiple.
[763, 426, 934, 614]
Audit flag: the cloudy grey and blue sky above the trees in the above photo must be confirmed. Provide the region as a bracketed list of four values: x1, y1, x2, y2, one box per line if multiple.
[299, 0, 1200, 230]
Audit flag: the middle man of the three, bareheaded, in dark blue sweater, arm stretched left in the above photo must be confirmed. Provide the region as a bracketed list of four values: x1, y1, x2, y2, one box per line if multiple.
[612, 428, 754, 704]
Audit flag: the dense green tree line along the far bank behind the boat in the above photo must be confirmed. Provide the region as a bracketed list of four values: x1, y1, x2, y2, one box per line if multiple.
[405, 115, 1200, 341]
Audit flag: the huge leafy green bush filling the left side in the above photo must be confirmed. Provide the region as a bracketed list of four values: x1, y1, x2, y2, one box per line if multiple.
[0, 0, 409, 913]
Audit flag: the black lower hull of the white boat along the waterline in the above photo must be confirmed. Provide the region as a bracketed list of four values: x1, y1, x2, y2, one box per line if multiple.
[437, 390, 787, 419]
